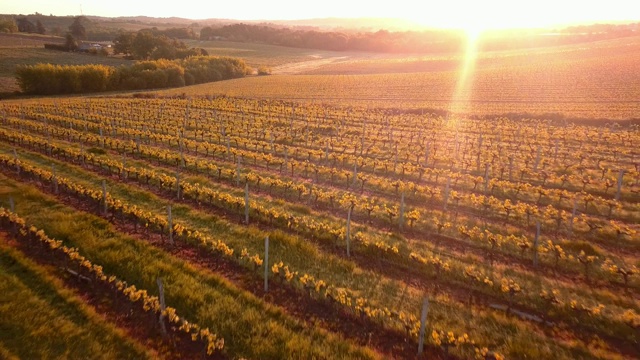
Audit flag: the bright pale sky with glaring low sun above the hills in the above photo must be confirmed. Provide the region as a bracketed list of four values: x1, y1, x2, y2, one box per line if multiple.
[0, 0, 640, 30]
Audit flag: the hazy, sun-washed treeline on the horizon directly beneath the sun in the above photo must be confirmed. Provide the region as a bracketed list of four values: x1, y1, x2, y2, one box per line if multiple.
[200, 24, 638, 53]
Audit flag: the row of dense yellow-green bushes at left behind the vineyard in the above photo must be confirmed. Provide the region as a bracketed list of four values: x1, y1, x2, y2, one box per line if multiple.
[16, 56, 252, 95]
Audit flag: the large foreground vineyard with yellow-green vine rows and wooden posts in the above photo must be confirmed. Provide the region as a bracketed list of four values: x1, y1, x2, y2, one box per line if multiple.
[0, 96, 640, 359]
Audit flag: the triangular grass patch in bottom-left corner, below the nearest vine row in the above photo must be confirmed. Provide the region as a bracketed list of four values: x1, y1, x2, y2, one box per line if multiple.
[0, 240, 157, 359]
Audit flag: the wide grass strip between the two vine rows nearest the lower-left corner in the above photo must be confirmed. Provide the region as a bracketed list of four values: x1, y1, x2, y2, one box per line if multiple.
[0, 176, 377, 359]
